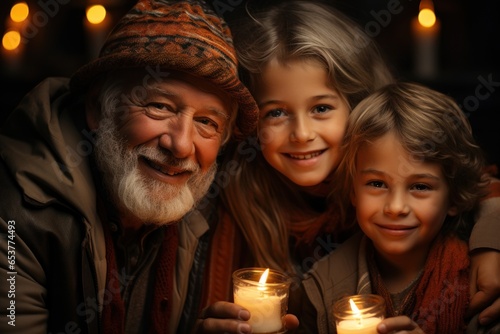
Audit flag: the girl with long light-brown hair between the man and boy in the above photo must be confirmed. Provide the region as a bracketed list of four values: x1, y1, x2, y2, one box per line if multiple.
[222, 1, 393, 275]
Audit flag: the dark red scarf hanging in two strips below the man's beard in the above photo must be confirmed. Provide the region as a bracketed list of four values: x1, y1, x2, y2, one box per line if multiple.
[102, 219, 178, 334]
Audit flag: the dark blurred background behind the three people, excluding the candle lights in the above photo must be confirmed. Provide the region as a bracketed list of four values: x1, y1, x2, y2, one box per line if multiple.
[0, 0, 500, 166]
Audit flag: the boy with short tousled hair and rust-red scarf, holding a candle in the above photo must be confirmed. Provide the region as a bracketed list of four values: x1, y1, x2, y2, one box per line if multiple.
[297, 83, 487, 333]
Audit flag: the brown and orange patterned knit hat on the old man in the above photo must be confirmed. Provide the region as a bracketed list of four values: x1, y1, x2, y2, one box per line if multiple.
[70, 0, 258, 137]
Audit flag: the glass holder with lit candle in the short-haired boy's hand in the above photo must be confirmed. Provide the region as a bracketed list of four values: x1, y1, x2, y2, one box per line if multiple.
[333, 294, 385, 334]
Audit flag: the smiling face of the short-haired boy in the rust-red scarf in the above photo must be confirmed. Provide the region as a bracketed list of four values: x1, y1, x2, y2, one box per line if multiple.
[352, 132, 456, 265]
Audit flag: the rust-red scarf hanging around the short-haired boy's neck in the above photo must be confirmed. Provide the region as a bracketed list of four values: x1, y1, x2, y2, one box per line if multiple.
[367, 236, 470, 333]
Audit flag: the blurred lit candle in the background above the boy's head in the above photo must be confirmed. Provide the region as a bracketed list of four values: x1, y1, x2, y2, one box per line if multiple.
[412, 0, 440, 79]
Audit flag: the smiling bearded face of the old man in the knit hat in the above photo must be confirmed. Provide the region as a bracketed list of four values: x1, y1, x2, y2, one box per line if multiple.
[89, 72, 232, 224]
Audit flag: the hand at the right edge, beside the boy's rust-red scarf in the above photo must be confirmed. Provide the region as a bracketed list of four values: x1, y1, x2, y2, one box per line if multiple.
[467, 249, 500, 325]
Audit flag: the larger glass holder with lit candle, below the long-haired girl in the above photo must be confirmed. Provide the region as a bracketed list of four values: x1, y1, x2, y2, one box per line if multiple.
[233, 268, 291, 333]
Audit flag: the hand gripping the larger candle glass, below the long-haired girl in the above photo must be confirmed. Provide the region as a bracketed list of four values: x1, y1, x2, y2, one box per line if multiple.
[195, 302, 299, 334]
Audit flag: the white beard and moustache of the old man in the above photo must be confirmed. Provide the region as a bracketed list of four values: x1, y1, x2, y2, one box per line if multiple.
[95, 117, 217, 225]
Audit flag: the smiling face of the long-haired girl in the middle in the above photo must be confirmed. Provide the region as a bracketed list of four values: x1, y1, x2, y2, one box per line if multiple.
[255, 60, 349, 186]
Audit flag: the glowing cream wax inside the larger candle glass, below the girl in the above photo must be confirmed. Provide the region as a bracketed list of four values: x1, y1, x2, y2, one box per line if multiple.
[234, 287, 284, 333]
